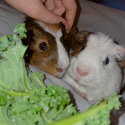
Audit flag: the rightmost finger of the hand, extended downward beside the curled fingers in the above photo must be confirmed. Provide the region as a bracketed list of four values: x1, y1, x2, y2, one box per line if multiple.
[62, 0, 77, 28]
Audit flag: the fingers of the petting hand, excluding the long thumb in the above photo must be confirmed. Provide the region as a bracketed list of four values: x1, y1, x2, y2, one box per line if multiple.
[44, 0, 77, 31]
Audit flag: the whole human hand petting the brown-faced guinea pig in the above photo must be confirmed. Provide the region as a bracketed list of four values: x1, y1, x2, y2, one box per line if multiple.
[5, 0, 77, 32]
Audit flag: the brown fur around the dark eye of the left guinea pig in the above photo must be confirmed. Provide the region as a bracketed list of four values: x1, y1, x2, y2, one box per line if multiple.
[24, 19, 58, 76]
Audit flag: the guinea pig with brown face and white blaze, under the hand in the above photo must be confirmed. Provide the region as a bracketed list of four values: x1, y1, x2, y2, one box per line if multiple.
[23, 17, 69, 77]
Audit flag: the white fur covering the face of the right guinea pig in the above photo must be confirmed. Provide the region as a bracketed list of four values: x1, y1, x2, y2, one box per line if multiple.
[63, 33, 122, 101]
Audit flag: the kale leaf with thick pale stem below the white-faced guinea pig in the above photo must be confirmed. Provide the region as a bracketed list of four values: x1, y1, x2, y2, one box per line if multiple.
[49, 93, 120, 125]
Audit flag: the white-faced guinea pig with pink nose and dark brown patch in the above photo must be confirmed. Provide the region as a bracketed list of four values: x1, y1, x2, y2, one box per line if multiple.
[63, 31, 125, 102]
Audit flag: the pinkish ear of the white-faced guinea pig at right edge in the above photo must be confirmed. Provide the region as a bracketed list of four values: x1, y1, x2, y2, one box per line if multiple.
[117, 46, 125, 68]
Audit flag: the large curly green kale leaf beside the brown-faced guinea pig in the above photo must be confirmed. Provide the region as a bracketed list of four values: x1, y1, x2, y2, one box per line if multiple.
[0, 24, 76, 125]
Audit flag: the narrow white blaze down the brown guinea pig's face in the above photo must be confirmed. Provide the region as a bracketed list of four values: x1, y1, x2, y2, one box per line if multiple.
[36, 21, 69, 77]
